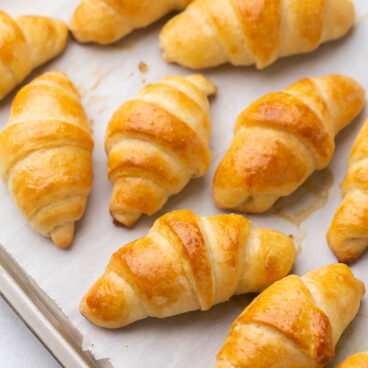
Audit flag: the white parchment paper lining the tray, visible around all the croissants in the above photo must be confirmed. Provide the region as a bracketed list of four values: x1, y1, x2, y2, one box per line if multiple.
[0, 0, 368, 368]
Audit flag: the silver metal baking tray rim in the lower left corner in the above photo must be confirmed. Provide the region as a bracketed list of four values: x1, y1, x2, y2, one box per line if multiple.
[0, 243, 113, 368]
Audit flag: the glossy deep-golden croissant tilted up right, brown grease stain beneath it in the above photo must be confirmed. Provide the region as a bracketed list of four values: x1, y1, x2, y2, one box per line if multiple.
[213, 75, 365, 212]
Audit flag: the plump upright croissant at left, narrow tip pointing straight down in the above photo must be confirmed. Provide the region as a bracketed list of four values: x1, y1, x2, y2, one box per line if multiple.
[0, 71, 93, 248]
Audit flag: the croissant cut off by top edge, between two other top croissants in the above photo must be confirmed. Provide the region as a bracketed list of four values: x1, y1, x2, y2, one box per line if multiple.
[69, 0, 192, 45]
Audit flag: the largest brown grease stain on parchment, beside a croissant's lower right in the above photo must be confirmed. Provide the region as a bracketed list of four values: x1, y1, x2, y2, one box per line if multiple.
[273, 168, 334, 248]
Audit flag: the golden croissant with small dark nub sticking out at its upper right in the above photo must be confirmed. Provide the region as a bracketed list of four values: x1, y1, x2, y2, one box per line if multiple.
[105, 75, 216, 226]
